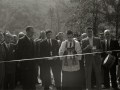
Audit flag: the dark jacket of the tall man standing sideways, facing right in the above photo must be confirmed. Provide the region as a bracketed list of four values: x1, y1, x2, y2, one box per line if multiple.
[17, 35, 36, 71]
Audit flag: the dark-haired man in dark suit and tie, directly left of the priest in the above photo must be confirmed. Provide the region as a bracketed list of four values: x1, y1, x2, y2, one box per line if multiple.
[40, 30, 61, 90]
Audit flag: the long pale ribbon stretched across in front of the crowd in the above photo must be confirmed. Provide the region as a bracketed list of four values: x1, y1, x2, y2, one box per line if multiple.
[0, 50, 120, 63]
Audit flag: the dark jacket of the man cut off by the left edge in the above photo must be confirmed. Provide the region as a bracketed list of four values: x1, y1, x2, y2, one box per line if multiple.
[0, 44, 6, 78]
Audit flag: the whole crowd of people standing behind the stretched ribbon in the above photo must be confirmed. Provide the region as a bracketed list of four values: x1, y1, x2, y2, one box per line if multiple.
[0, 26, 120, 90]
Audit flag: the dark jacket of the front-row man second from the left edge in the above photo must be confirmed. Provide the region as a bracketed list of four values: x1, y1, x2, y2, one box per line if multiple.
[3, 43, 16, 74]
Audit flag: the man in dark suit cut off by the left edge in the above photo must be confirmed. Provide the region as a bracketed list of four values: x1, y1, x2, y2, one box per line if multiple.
[0, 32, 6, 90]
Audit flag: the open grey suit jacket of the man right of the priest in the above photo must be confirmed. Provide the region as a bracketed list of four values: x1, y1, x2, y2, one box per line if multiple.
[82, 37, 102, 66]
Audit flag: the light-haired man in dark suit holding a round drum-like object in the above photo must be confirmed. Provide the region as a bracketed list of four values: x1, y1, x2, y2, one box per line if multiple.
[102, 30, 119, 90]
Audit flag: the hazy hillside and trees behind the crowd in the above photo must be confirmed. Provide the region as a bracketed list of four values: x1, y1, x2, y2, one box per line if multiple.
[0, 0, 120, 37]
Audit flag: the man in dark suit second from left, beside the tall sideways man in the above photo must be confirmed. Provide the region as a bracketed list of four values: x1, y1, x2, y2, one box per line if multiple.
[3, 32, 16, 90]
